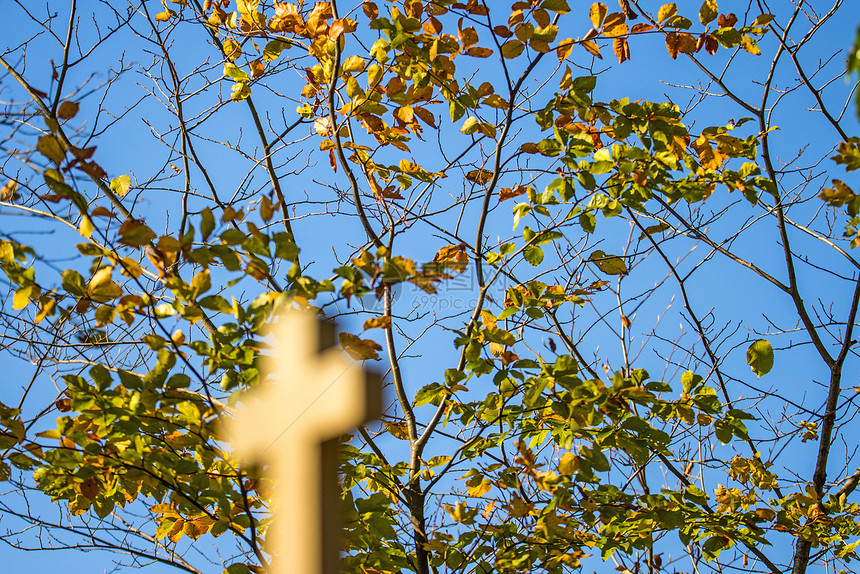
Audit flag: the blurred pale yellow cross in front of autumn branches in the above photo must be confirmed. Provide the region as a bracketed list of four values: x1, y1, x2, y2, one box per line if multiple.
[228, 311, 382, 574]
